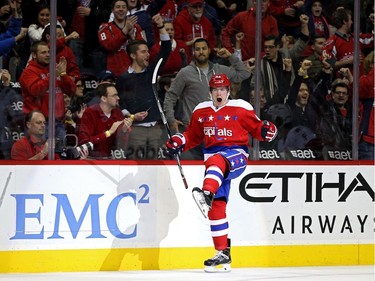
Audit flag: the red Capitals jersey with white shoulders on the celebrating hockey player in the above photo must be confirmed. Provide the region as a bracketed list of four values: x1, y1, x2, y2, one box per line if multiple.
[184, 99, 263, 152]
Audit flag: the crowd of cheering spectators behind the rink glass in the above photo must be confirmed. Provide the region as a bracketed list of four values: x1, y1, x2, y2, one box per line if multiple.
[0, 0, 375, 160]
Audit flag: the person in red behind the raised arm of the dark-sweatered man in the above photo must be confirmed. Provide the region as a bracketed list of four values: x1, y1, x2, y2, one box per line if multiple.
[150, 22, 190, 76]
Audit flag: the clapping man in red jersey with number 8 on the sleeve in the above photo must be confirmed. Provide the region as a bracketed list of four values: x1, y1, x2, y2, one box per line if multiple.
[98, 0, 143, 77]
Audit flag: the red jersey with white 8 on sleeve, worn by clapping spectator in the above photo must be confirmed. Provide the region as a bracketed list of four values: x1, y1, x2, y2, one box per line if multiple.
[98, 22, 144, 77]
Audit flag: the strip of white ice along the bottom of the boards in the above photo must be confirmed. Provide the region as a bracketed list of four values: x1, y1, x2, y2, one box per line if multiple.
[0, 265, 375, 281]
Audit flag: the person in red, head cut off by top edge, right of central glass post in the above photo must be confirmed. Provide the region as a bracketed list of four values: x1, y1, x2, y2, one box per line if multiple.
[269, 0, 304, 38]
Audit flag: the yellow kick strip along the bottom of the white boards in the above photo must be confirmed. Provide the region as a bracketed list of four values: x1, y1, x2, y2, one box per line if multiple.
[0, 244, 374, 273]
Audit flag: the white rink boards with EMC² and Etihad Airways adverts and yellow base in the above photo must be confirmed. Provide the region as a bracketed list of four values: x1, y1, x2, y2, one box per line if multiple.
[0, 161, 375, 272]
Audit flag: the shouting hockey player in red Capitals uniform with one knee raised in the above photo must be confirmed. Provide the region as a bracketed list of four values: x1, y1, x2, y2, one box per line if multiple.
[166, 74, 277, 272]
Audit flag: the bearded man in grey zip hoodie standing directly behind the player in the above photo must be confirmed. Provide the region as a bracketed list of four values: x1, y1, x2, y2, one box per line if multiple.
[164, 38, 250, 159]
